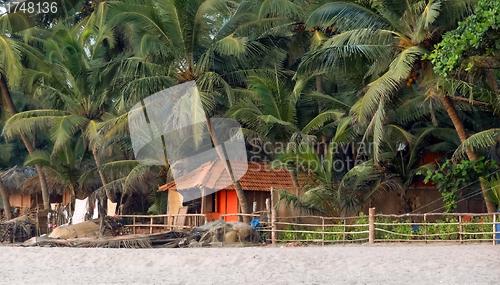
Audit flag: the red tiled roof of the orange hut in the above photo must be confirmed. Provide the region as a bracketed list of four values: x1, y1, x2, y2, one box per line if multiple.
[159, 159, 293, 191]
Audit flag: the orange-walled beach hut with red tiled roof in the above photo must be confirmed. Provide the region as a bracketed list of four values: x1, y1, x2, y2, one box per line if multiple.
[159, 159, 297, 221]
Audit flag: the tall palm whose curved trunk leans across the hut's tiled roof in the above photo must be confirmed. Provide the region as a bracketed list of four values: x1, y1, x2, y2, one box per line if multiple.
[96, 0, 297, 221]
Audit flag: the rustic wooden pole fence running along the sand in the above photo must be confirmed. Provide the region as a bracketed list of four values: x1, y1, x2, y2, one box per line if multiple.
[115, 208, 500, 245]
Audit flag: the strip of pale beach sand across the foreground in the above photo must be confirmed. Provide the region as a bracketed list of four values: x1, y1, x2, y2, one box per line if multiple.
[0, 244, 500, 284]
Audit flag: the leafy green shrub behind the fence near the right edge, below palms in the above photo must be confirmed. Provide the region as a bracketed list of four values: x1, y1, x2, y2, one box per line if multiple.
[418, 157, 498, 213]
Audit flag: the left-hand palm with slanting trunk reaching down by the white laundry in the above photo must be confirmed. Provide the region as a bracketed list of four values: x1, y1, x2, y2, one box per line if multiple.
[3, 23, 123, 201]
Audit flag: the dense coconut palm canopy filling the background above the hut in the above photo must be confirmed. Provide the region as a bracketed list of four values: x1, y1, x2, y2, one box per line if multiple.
[0, 0, 500, 213]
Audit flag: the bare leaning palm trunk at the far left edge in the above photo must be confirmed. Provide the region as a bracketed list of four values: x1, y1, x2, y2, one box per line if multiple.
[0, 73, 50, 210]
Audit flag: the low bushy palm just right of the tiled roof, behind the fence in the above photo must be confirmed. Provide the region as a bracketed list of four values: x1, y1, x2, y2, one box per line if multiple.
[271, 141, 400, 217]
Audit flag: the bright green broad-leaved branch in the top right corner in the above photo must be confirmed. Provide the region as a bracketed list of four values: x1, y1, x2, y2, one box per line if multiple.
[429, 0, 500, 76]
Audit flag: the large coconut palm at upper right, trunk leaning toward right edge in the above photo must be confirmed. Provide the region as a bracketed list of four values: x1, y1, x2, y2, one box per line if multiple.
[292, 0, 500, 212]
